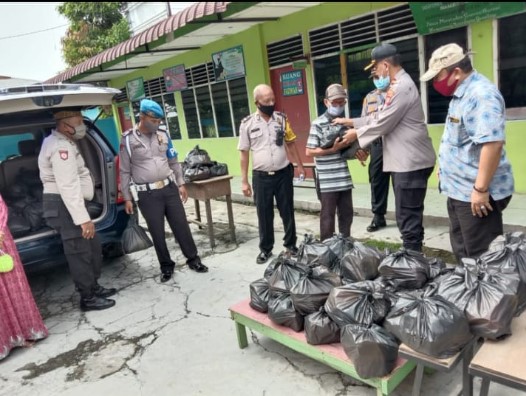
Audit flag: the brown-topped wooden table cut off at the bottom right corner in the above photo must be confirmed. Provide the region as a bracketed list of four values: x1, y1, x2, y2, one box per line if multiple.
[469, 312, 526, 396]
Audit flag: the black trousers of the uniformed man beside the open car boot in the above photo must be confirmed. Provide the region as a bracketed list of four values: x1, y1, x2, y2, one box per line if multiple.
[42, 194, 102, 298]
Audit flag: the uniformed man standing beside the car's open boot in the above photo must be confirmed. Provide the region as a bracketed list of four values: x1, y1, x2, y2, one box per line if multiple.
[38, 109, 117, 311]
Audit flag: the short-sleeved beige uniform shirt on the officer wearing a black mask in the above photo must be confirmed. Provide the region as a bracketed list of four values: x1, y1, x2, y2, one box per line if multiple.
[237, 111, 296, 172]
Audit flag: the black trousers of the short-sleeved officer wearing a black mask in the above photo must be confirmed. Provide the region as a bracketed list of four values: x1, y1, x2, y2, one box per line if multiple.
[252, 164, 297, 252]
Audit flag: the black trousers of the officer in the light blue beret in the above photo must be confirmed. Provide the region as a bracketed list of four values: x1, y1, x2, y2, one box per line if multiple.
[138, 183, 200, 271]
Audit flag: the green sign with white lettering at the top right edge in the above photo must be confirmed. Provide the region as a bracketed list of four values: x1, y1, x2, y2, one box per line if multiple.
[409, 1, 526, 35]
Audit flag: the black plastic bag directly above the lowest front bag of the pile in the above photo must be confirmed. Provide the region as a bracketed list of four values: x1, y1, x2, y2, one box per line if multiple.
[325, 281, 391, 327]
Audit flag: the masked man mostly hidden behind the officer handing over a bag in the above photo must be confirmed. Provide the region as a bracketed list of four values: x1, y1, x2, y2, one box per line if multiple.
[362, 73, 391, 232]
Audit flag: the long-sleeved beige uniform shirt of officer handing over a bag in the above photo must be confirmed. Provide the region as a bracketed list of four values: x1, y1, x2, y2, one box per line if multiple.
[353, 69, 436, 172]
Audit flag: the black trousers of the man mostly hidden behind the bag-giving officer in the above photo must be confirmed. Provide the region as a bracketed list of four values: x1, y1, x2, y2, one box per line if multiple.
[369, 138, 391, 219]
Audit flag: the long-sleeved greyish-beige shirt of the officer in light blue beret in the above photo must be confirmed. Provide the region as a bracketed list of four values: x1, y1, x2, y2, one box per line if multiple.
[119, 127, 185, 201]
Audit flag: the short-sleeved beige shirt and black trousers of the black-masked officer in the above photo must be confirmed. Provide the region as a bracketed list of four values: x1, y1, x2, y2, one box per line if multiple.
[238, 111, 297, 253]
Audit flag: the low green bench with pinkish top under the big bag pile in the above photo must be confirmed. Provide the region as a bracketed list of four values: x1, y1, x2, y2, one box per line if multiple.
[229, 299, 416, 395]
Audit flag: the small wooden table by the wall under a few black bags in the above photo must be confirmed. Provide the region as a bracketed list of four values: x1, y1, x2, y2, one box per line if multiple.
[185, 175, 237, 248]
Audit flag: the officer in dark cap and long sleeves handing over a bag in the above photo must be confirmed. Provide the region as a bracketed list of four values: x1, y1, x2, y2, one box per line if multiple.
[337, 44, 436, 251]
